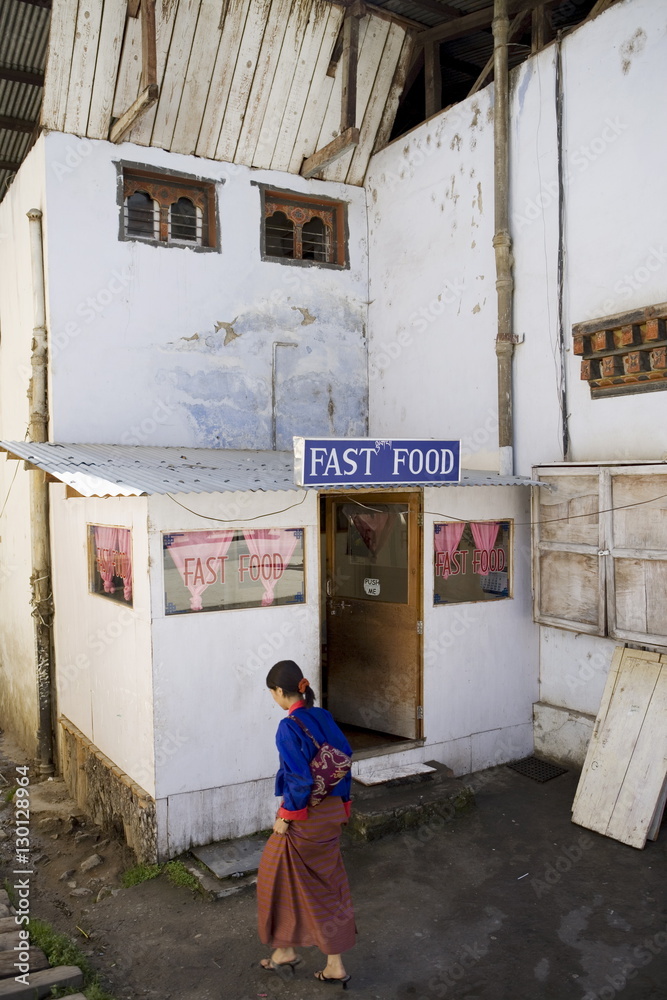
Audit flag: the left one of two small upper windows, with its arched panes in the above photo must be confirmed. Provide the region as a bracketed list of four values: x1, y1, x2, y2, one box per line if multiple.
[121, 167, 217, 249]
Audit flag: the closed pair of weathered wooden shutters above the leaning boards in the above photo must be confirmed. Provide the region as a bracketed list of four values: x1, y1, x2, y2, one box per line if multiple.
[533, 465, 667, 646]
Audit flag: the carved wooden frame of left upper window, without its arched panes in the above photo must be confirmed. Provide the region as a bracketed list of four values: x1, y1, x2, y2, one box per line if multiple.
[120, 165, 218, 250]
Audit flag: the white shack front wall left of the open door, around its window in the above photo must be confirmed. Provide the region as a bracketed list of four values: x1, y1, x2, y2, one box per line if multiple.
[148, 490, 321, 856]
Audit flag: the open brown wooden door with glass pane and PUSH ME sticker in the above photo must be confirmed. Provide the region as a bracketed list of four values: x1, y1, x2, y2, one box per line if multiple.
[326, 493, 421, 739]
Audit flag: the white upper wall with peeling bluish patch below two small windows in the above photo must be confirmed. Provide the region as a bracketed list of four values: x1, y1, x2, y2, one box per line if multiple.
[46, 133, 368, 448]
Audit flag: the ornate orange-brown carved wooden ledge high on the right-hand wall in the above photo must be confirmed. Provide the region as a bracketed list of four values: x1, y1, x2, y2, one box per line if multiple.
[572, 302, 667, 399]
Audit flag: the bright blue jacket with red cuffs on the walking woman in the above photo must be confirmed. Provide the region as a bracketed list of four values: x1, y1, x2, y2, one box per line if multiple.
[276, 706, 352, 819]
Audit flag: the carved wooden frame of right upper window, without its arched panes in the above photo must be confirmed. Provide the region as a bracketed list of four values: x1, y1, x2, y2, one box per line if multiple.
[261, 188, 349, 268]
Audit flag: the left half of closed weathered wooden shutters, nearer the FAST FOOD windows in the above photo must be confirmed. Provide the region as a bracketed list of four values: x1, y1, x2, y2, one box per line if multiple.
[533, 467, 608, 635]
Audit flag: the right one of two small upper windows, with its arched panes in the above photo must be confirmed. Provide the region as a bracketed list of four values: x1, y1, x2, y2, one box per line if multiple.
[261, 188, 347, 267]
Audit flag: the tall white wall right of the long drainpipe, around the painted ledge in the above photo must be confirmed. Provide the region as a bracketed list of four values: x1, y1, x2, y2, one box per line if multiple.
[511, 0, 667, 474]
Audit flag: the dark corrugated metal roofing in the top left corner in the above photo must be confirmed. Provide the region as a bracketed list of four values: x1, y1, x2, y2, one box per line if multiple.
[0, 0, 51, 199]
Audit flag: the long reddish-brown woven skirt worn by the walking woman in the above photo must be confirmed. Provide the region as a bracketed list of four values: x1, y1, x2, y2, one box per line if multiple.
[257, 796, 356, 955]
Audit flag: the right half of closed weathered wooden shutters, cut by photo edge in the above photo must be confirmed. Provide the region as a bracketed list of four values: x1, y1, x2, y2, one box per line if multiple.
[602, 466, 667, 646]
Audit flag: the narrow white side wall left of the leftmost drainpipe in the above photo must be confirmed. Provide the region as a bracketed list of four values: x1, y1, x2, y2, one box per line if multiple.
[0, 139, 45, 753]
